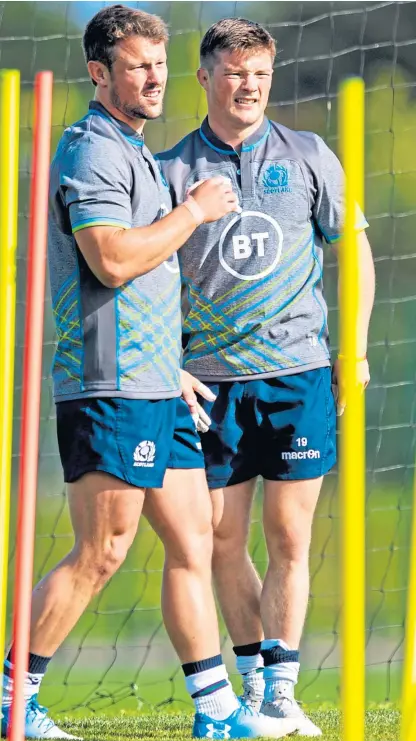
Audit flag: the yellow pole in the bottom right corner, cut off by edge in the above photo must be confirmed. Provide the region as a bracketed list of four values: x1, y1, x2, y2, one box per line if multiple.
[401, 468, 416, 741]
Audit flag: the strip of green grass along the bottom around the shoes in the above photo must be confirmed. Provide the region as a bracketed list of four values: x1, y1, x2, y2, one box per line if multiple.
[54, 707, 399, 741]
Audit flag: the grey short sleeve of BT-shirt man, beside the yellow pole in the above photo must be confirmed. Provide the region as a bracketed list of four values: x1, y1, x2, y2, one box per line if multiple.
[312, 136, 368, 244]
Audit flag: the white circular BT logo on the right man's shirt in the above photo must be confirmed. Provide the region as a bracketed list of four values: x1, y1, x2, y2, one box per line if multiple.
[218, 211, 283, 280]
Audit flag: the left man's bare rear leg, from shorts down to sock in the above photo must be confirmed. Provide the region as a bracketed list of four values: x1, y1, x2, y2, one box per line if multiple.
[30, 472, 144, 656]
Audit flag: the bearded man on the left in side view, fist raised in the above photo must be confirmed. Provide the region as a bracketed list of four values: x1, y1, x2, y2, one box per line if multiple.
[2, 5, 296, 738]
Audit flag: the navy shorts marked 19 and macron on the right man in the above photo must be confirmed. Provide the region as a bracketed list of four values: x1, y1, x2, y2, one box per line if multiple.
[197, 367, 336, 489]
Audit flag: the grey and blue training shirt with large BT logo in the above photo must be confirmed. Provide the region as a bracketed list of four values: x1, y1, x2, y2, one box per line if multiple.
[157, 119, 367, 382]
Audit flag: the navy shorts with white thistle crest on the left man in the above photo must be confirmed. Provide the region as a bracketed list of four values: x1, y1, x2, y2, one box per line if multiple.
[56, 398, 204, 488]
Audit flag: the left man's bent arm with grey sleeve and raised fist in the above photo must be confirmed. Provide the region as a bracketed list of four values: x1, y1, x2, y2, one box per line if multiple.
[57, 132, 237, 288]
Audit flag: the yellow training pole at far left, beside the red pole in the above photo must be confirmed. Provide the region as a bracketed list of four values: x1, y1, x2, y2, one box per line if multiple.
[0, 70, 20, 700]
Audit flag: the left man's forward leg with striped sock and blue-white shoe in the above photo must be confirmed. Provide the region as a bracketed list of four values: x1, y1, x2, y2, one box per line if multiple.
[143, 469, 297, 738]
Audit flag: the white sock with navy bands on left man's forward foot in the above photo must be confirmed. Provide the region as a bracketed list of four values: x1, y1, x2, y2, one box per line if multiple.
[185, 664, 240, 720]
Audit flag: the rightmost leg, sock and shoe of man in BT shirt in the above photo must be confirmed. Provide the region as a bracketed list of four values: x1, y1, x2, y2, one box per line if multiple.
[261, 477, 322, 736]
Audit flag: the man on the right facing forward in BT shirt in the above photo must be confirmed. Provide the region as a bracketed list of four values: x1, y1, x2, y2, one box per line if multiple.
[158, 18, 374, 736]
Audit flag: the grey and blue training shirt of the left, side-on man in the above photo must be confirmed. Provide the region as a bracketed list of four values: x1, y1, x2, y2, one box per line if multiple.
[48, 102, 181, 401]
